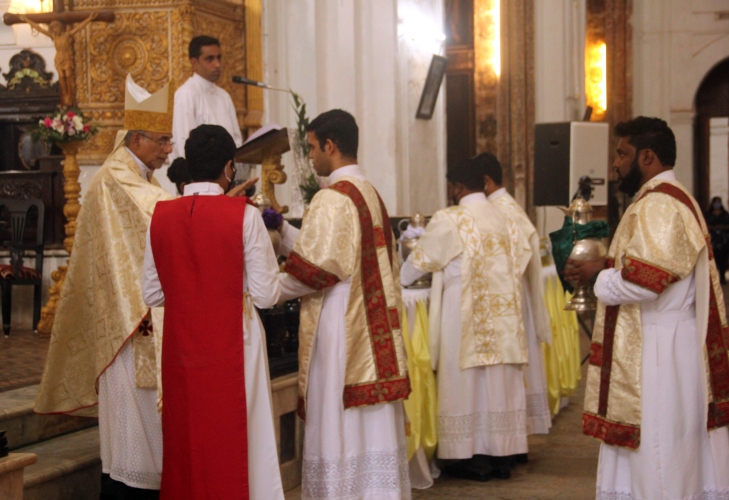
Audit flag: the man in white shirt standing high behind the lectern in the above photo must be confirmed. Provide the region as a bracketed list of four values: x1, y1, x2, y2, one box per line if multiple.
[170, 36, 243, 160]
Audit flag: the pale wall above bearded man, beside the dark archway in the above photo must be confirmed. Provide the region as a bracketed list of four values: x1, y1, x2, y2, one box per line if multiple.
[633, 0, 729, 194]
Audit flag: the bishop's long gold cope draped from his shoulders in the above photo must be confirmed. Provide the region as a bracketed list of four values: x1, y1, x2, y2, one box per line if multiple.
[35, 146, 172, 416]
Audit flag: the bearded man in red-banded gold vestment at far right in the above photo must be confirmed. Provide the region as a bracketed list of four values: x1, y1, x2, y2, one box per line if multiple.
[564, 117, 729, 500]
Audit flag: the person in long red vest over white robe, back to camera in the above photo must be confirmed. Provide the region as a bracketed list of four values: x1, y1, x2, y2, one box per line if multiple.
[142, 125, 283, 500]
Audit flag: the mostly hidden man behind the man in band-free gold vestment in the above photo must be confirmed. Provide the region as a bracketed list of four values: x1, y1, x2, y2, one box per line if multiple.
[474, 153, 552, 442]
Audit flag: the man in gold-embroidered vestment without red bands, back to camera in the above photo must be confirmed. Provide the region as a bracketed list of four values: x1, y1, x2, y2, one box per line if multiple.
[400, 160, 529, 481]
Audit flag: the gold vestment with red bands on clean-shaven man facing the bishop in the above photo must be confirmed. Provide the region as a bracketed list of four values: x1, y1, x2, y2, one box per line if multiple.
[285, 176, 410, 418]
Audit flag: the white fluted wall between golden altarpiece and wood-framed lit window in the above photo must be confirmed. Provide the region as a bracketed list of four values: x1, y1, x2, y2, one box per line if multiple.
[263, 0, 445, 216]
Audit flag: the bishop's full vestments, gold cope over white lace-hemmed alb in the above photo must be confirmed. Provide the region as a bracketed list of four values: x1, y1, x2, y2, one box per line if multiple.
[35, 145, 171, 489]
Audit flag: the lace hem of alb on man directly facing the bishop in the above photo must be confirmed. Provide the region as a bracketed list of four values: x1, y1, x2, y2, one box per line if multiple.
[301, 446, 410, 500]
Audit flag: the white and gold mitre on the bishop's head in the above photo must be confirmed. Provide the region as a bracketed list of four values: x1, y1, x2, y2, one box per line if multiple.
[124, 74, 175, 134]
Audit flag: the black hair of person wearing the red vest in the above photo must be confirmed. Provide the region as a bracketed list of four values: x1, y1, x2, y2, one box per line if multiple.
[185, 125, 235, 182]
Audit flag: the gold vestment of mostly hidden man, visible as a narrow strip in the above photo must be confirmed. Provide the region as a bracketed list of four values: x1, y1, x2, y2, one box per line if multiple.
[489, 190, 552, 344]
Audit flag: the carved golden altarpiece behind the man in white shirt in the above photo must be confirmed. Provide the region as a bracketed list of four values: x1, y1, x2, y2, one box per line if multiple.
[67, 0, 263, 165]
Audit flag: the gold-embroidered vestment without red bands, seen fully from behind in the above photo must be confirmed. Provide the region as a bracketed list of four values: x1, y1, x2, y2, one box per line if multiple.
[410, 197, 528, 370]
